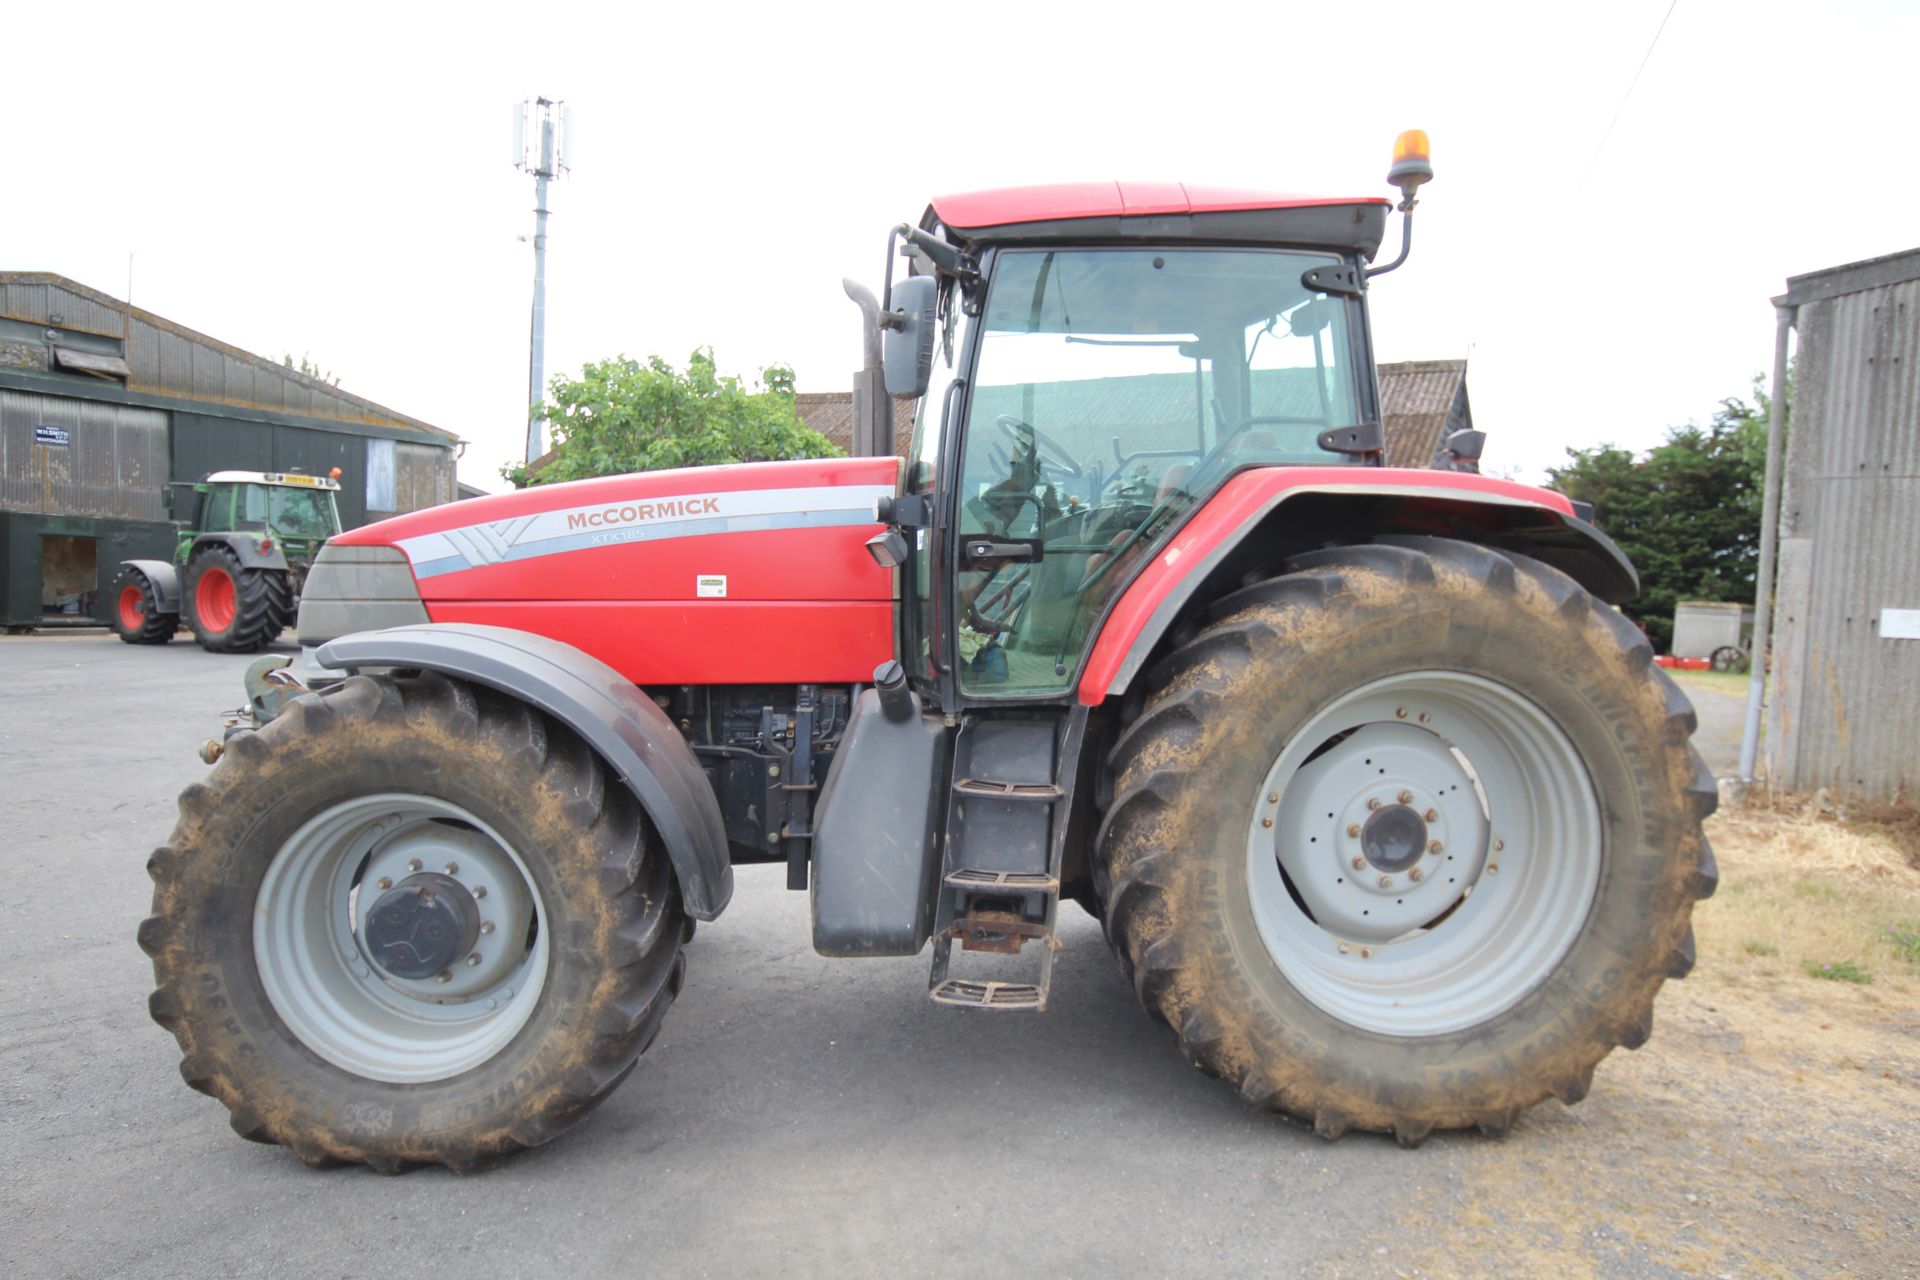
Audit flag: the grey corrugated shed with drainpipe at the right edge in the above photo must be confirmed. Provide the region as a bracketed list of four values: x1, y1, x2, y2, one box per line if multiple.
[1766, 249, 1920, 802]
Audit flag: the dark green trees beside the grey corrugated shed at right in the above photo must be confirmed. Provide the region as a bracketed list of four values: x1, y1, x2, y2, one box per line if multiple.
[1549, 378, 1768, 649]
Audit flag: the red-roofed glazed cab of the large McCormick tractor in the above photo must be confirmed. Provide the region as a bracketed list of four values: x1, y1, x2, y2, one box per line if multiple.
[879, 184, 1388, 706]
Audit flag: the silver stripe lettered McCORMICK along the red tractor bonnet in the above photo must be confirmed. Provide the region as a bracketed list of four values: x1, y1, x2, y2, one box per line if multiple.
[397, 486, 893, 578]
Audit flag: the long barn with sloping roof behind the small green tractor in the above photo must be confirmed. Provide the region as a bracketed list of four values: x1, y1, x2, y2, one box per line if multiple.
[0, 273, 459, 626]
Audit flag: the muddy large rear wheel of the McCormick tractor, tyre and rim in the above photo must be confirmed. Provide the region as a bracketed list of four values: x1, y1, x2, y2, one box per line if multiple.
[1096, 537, 1716, 1144]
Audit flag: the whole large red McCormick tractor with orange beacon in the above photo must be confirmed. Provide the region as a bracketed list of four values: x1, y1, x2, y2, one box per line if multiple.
[140, 134, 1716, 1173]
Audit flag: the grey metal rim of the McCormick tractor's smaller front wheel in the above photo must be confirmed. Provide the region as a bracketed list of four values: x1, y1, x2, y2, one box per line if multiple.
[253, 793, 551, 1084]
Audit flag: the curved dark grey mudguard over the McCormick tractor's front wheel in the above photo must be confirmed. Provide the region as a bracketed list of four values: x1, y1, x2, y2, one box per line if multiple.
[315, 622, 733, 919]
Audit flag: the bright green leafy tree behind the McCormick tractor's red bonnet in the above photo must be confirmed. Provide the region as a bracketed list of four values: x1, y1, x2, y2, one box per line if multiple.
[501, 347, 839, 486]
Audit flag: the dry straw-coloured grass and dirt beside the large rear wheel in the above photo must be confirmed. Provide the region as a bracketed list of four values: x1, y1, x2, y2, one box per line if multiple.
[1382, 806, 1920, 1276]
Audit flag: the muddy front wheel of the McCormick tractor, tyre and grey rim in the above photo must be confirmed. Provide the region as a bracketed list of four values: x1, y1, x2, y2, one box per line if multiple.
[129, 674, 684, 1173]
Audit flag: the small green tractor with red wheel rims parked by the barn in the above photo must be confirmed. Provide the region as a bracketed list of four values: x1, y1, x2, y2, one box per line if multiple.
[108, 466, 340, 652]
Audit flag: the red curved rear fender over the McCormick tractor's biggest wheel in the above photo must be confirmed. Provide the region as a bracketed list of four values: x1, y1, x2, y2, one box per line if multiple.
[1079, 466, 1640, 706]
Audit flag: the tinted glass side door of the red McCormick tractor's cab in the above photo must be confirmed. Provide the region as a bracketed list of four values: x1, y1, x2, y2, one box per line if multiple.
[956, 249, 1359, 697]
